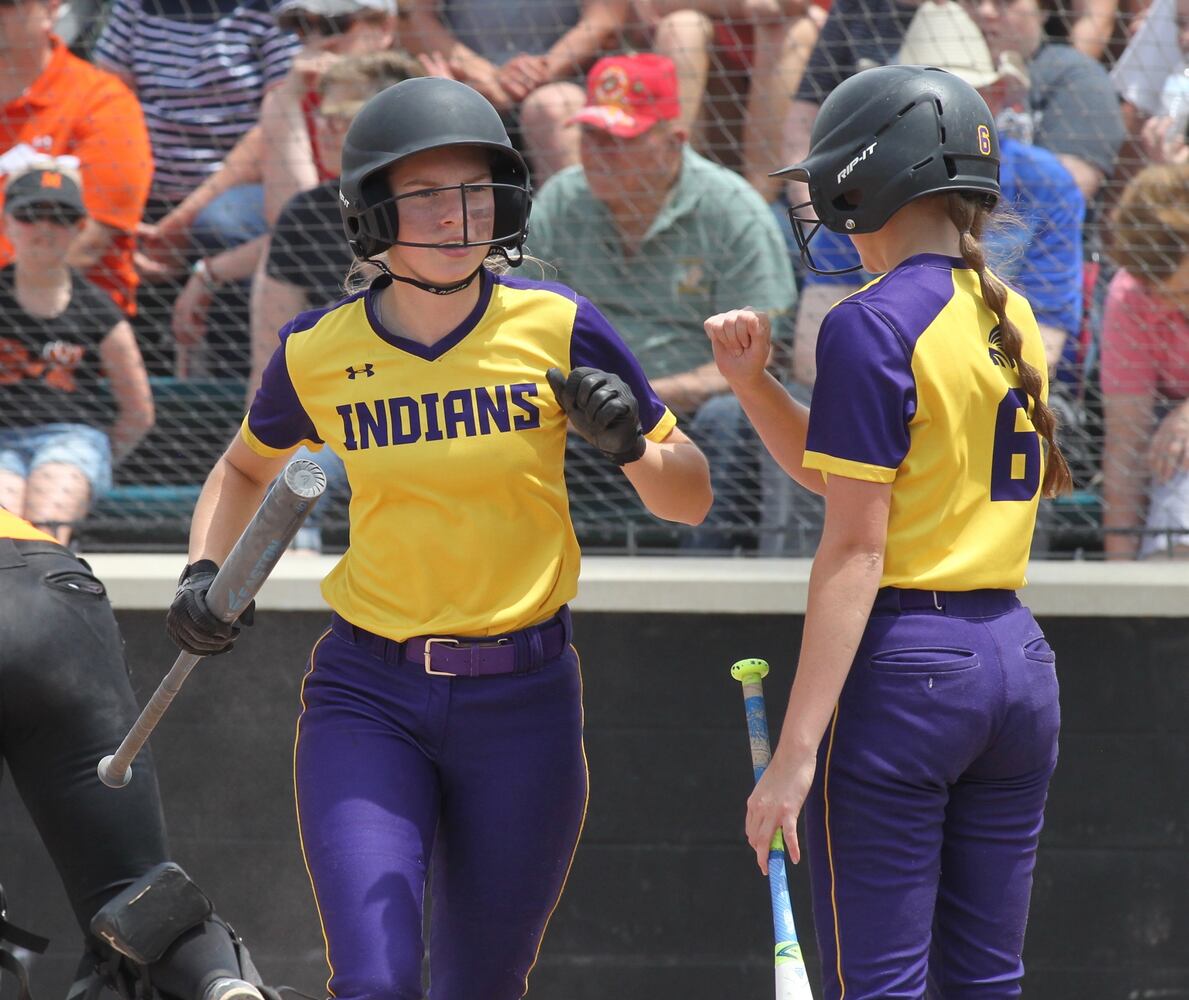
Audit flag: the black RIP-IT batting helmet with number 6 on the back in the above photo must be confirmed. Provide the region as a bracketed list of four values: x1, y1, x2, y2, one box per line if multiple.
[772, 65, 999, 268]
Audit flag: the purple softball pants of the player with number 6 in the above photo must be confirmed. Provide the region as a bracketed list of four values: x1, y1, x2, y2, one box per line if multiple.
[805, 589, 1059, 1000]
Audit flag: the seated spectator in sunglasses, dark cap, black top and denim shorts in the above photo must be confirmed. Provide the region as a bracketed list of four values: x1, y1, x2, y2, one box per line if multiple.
[0, 163, 153, 543]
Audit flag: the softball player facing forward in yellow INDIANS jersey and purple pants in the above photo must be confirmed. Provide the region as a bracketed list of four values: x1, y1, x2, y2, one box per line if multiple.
[169, 77, 711, 1000]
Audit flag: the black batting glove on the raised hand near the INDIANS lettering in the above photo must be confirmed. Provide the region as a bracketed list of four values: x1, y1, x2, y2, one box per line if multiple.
[545, 367, 647, 465]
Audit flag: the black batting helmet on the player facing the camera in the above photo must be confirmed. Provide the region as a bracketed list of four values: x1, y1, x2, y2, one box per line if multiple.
[339, 76, 531, 259]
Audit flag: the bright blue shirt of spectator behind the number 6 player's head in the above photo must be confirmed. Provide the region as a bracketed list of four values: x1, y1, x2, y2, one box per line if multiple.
[805, 136, 1086, 378]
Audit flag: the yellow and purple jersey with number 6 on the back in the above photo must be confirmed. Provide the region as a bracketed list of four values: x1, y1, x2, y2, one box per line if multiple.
[804, 253, 1048, 591]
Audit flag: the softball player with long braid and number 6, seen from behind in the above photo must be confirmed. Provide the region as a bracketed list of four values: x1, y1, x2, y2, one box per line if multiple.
[706, 67, 1069, 1000]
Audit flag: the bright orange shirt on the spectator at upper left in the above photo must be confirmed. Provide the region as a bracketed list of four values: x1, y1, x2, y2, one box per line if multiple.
[0, 36, 152, 315]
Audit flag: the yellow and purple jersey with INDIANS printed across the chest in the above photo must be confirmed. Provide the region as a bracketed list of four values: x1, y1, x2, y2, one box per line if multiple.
[241, 270, 677, 640]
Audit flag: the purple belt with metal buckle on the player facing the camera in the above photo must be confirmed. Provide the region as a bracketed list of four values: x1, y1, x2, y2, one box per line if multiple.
[331, 605, 573, 677]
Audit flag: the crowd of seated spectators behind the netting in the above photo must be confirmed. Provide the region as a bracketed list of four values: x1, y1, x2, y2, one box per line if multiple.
[0, 0, 1189, 559]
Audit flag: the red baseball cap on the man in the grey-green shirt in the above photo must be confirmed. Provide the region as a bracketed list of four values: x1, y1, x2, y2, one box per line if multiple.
[566, 52, 681, 139]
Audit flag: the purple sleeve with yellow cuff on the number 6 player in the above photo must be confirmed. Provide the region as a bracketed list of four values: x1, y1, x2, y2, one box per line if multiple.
[805, 302, 917, 473]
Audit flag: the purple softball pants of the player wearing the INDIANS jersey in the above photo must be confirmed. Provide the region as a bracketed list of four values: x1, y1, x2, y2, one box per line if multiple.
[287, 618, 587, 1000]
